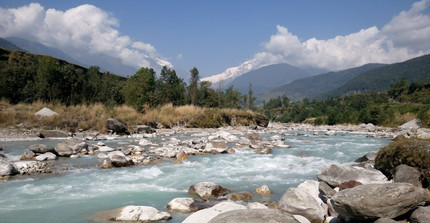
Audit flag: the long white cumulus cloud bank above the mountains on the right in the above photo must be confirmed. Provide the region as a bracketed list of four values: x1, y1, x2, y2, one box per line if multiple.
[204, 0, 430, 82]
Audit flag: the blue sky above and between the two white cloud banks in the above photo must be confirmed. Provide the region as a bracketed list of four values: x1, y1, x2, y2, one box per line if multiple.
[0, 0, 430, 80]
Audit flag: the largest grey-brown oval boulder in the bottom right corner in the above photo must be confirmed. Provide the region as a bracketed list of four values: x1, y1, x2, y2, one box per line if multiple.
[331, 183, 430, 220]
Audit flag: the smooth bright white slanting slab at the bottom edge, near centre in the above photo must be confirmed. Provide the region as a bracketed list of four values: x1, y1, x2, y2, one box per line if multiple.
[182, 201, 246, 223]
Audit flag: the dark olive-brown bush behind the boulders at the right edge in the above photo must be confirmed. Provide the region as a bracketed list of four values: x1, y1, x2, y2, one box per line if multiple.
[375, 139, 430, 187]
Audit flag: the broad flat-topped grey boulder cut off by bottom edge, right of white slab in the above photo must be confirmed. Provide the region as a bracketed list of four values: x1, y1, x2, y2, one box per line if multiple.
[209, 209, 300, 223]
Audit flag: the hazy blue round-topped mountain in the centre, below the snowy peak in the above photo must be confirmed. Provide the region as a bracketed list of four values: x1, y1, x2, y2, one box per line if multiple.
[229, 63, 311, 94]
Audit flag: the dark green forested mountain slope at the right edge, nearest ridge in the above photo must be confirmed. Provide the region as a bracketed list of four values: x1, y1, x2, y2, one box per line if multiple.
[319, 54, 430, 98]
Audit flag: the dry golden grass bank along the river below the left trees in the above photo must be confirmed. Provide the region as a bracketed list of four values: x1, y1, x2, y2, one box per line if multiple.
[0, 100, 256, 132]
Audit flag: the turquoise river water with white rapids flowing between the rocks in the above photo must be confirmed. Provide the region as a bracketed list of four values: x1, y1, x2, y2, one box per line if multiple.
[0, 133, 389, 223]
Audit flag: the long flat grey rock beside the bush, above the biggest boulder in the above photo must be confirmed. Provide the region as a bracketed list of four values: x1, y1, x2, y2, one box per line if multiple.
[317, 164, 388, 187]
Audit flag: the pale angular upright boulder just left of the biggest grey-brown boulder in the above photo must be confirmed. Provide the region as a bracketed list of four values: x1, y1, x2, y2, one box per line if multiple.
[278, 181, 327, 223]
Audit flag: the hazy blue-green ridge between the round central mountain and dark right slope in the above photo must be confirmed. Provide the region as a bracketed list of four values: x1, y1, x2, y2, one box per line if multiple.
[263, 64, 385, 101]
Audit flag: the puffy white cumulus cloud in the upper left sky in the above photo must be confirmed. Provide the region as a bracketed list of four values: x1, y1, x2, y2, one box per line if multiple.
[0, 3, 172, 71]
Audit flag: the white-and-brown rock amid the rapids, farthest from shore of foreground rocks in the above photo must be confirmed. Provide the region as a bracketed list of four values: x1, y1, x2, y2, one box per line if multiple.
[188, 182, 230, 199]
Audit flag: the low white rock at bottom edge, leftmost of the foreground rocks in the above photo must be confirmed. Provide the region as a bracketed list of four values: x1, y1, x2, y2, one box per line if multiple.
[116, 206, 172, 222]
